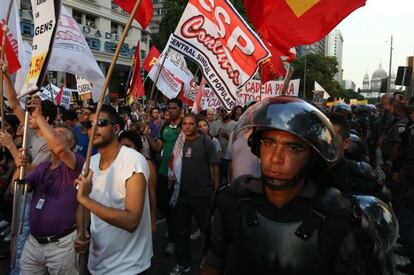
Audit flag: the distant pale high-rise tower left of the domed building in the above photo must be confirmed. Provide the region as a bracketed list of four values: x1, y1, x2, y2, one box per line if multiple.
[325, 29, 344, 83]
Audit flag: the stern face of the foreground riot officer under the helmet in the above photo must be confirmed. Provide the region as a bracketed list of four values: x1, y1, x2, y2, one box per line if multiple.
[260, 130, 312, 180]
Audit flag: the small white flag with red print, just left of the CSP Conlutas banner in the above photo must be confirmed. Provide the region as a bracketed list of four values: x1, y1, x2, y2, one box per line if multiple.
[148, 41, 194, 99]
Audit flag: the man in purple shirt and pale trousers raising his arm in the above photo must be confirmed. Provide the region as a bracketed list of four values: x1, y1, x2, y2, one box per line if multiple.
[17, 98, 84, 275]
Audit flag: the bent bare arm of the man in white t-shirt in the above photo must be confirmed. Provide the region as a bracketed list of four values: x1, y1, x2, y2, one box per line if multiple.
[75, 171, 146, 233]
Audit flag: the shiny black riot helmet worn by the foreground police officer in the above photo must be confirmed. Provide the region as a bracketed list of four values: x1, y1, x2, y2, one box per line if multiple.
[235, 96, 338, 163]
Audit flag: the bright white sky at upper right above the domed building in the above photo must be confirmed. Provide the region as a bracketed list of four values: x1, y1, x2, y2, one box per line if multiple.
[336, 0, 414, 88]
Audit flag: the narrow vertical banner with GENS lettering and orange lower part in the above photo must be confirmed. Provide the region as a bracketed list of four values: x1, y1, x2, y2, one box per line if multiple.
[21, 0, 61, 94]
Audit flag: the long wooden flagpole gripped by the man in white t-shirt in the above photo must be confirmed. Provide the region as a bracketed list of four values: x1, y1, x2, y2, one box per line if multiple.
[79, 0, 141, 275]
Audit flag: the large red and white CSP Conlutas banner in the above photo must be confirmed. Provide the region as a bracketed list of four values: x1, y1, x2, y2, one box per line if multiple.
[169, 0, 270, 110]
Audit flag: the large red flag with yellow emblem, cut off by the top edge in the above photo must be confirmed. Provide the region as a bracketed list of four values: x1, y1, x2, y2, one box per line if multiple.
[244, 0, 366, 68]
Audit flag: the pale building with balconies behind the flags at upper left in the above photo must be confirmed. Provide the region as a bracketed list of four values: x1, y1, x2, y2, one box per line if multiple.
[17, 0, 150, 96]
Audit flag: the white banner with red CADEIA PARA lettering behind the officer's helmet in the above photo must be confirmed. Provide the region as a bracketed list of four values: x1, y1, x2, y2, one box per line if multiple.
[200, 79, 300, 110]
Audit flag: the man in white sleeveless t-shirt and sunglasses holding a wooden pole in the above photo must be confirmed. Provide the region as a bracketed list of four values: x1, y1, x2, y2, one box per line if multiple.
[75, 105, 152, 275]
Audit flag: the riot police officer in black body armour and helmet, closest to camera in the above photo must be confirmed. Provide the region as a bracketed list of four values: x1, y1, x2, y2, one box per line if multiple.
[201, 97, 396, 275]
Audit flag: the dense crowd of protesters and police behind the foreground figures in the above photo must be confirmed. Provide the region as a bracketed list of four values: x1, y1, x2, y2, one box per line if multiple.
[0, 58, 414, 274]
